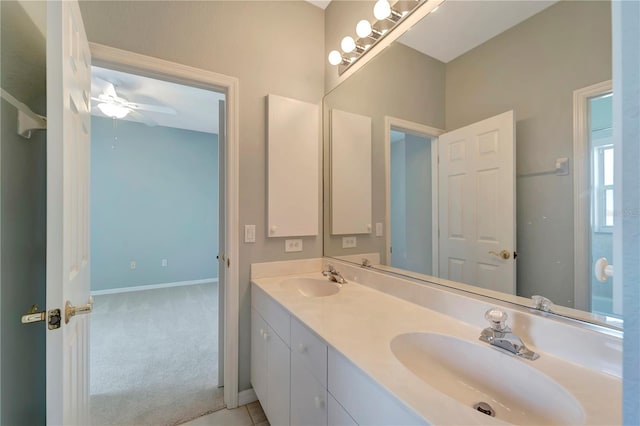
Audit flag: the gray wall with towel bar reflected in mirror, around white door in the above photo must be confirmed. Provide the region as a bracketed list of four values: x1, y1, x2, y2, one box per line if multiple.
[446, 1, 612, 306]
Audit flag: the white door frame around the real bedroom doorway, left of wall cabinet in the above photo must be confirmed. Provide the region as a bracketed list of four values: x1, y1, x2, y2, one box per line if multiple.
[89, 43, 240, 408]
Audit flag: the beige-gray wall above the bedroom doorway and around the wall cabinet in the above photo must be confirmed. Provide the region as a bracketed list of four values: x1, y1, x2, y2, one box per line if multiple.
[80, 1, 325, 391]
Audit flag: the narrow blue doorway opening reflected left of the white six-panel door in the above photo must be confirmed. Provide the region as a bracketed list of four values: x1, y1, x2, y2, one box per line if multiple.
[389, 128, 434, 275]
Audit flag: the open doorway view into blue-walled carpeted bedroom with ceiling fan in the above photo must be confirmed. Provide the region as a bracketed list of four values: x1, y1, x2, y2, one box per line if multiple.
[90, 67, 225, 424]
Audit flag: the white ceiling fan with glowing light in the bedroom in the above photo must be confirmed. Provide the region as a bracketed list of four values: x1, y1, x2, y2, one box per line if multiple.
[91, 77, 176, 126]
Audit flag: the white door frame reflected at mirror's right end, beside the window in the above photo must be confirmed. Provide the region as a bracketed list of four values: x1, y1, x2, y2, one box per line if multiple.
[573, 80, 613, 311]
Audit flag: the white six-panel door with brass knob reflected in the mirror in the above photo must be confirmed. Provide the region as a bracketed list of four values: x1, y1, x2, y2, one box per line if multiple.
[438, 111, 516, 294]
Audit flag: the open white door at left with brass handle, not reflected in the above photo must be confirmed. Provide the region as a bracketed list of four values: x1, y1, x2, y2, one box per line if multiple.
[47, 1, 91, 425]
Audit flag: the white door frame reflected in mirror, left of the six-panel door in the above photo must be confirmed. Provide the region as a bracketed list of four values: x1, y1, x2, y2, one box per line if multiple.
[384, 116, 444, 276]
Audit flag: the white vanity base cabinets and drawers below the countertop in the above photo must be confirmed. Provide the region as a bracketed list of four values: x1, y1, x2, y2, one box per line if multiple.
[251, 284, 426, 426]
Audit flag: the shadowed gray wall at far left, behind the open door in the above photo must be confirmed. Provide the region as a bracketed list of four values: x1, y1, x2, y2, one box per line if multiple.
[0, 1, 46, 425]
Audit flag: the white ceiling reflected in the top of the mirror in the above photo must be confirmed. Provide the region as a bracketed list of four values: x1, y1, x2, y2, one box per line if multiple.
[398, 0, 557, 63]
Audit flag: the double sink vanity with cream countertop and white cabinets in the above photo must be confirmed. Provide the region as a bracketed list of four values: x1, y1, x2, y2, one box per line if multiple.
[251, 259, 622, 425]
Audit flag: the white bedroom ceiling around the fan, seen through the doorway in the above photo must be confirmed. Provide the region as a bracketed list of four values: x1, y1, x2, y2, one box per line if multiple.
[91, 66, 224, 134]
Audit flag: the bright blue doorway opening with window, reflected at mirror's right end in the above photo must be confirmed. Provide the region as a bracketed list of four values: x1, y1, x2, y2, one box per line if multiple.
[588, 92, 620, 316]
